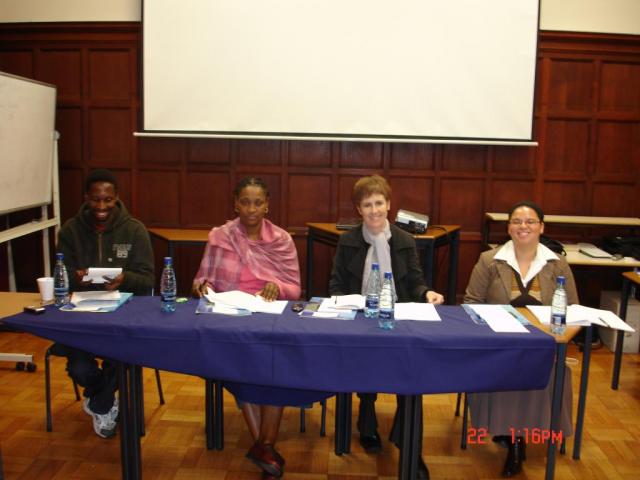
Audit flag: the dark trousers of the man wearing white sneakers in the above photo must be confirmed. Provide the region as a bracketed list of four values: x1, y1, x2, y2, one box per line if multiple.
[53, 343, 116, 415]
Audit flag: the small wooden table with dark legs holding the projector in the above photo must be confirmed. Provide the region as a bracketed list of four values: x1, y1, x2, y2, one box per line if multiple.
[307, 223, 460, 305]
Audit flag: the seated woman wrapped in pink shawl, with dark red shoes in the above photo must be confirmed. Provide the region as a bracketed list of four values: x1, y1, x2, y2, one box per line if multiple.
[193, 177, 300, 479]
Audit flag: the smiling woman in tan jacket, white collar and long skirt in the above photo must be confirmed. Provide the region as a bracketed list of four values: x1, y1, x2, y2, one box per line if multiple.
[464, 201, 578, 477]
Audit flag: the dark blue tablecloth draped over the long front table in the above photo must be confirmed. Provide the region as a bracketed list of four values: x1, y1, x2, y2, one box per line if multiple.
[4, 297, 555, 405]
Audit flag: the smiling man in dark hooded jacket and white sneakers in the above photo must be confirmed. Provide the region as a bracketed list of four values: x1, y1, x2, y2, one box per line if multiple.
[54, 169, 155, 438]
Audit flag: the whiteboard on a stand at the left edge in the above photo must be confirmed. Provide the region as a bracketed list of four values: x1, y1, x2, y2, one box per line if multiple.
[0, 72, 56, 214]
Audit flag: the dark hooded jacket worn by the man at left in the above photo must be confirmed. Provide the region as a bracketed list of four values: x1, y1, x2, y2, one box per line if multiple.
[58, 200, 155, 295]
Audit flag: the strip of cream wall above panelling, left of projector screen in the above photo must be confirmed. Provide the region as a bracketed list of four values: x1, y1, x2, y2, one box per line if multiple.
[0, 0, 142, 23]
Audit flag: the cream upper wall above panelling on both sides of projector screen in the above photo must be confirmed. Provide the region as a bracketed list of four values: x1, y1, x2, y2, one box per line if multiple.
[0, 0, 640, 35]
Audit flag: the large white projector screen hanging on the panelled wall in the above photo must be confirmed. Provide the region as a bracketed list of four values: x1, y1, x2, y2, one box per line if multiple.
[143, 0, 539, 143]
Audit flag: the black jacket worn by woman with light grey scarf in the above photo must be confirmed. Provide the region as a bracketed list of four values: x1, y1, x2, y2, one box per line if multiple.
[329, 225, 431, 302]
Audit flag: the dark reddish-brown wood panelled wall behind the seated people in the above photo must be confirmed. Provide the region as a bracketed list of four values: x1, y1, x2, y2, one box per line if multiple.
[0, 23, 640, 302]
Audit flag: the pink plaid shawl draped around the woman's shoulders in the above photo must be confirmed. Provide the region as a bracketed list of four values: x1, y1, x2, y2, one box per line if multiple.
[195, 218, 300, 300]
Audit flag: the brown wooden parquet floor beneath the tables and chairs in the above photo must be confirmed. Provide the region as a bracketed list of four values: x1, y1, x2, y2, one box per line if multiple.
[0, 332, 640, 480]
